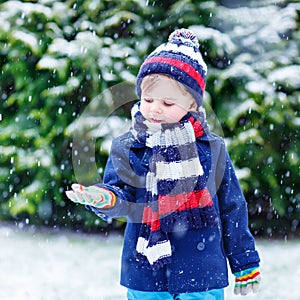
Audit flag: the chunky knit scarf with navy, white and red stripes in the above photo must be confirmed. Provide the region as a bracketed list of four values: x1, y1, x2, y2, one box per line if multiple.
[131, 103, 218, 270]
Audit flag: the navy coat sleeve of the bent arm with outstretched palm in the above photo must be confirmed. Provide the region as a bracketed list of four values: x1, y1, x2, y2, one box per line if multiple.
[87, 136, 141, 221]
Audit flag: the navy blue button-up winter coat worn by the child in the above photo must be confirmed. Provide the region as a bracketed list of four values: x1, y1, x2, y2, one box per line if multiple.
[92, 132, 260, 293]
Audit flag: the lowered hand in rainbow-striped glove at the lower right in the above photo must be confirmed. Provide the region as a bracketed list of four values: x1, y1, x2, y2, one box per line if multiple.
[234, 268, 261, 295]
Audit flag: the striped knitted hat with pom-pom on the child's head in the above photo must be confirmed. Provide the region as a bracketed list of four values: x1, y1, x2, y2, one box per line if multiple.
[136, 29, 207, 106]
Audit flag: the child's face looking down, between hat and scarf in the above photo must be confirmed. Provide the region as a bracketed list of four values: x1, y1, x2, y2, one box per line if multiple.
[140, 75, 196, 123]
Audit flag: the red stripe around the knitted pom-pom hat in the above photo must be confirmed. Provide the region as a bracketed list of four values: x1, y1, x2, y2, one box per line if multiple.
[142, 57, 205, 91]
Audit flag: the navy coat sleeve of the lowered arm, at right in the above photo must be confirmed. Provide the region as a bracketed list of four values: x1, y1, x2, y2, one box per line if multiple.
[217, 145, 260, 273]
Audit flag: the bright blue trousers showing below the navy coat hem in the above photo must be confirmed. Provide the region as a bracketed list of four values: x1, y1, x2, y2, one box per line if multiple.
[127, 289, 224, 300]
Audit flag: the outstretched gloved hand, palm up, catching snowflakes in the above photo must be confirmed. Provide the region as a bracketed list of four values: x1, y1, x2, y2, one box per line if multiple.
[66, 183, 116, 209]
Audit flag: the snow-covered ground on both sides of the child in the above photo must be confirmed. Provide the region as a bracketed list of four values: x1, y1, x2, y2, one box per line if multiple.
[0, 224, 300, 300]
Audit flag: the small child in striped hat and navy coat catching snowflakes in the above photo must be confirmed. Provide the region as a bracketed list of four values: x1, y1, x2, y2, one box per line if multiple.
[66, 29, 260, 300]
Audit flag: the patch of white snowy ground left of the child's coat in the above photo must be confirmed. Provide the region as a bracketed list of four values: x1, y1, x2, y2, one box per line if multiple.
[0, 227, 125, 300]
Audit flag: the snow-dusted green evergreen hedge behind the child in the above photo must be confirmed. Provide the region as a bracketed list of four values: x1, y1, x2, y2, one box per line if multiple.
[0, 0, 300, 235]
